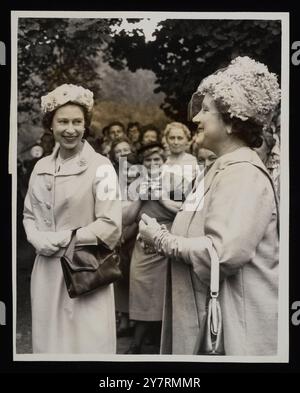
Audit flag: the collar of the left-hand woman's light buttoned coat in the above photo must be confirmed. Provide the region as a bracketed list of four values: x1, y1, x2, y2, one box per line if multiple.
[36, 141, 96, 176]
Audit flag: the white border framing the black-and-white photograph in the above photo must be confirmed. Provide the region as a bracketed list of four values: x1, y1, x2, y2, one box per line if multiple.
[9, 11, 290, 363]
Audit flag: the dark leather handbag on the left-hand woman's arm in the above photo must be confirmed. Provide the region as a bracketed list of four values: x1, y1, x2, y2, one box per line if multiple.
[60, 230, 122, 298]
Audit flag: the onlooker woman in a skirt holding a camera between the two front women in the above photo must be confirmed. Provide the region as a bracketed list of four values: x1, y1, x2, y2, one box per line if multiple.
[124, 143, 179, 354]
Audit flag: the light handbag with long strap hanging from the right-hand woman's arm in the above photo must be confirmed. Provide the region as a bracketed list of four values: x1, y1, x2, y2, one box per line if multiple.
[194, 242, 225, 355]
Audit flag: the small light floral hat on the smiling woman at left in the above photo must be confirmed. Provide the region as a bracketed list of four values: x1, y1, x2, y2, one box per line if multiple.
[41, 84, 94, 113]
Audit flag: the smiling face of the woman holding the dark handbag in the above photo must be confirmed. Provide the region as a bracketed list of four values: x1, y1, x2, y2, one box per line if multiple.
[51, 104, 85, 157]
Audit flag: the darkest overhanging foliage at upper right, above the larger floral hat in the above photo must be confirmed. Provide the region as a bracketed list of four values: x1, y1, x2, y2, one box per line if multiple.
[108, 19, 281, 121]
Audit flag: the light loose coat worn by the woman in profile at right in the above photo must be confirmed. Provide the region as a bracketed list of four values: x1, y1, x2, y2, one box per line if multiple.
[161, 147, 278, 355]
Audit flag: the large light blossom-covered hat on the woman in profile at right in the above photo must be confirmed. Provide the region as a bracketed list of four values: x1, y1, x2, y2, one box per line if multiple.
[196, 56, 280, 125]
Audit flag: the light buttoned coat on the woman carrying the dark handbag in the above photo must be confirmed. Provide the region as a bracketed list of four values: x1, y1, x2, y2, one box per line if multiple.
[24, 141, 122, 353]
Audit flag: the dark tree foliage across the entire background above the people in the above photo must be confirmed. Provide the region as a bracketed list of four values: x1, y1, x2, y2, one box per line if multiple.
[18, 18, 281, 148]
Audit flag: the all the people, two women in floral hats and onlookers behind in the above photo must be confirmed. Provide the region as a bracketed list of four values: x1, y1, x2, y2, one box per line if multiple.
[20, 57, 280, 355]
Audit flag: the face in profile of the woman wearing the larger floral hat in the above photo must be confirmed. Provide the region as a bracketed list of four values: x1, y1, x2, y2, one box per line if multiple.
[193, 94, 228, 153]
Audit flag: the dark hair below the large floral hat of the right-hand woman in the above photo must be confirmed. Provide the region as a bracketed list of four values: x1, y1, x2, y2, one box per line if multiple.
[215, 100, 263, 148]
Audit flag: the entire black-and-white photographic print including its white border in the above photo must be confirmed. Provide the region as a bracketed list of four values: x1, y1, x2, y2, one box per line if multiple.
[9, 11, 290, 363]
